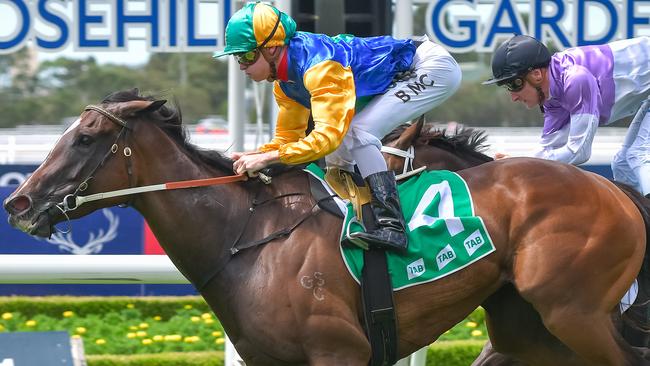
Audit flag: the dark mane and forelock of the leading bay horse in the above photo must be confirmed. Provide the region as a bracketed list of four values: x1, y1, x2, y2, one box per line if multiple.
[102, 89, 232, 171]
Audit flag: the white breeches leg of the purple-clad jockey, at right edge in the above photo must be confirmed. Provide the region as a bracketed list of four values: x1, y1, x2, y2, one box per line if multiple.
[612, 99, 650, 195]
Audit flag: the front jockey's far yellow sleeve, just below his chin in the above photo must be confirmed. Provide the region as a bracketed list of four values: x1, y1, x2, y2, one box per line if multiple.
[258, 81, 309, 152]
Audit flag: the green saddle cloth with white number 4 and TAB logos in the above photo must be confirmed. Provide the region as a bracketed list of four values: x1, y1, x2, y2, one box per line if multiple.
[305, 164, 495, 290]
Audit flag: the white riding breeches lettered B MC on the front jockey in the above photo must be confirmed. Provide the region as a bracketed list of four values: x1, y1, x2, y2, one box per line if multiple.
[325, 38, 461, 177]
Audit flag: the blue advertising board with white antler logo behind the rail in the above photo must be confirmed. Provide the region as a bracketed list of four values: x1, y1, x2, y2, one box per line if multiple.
[0, 165, 196, 296]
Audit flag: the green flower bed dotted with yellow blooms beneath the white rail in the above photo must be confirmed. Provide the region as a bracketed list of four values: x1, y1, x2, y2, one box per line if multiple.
[0, 296, 487, 365]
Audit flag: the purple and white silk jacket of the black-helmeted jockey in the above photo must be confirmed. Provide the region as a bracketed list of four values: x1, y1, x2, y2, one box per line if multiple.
[535, 37, 650, 168]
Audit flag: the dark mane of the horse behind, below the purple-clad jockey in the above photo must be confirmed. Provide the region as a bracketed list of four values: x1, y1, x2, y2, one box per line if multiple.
[381, 123, 494, 162]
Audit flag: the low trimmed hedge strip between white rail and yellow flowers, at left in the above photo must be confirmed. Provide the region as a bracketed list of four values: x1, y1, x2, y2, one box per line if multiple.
[0, 296, 210, 318]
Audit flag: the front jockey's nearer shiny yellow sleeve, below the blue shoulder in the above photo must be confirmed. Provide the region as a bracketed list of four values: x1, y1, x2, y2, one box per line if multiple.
[278, 61, 356, 164]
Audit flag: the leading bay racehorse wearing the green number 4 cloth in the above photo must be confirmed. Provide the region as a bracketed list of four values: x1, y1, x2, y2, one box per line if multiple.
[4, 92, 648, 366]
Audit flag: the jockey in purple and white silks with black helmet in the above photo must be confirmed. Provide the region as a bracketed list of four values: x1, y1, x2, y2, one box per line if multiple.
[484, 35, 650, 195]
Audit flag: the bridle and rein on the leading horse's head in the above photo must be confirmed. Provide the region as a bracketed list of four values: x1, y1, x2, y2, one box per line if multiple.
[55, 105, 248, 214]
